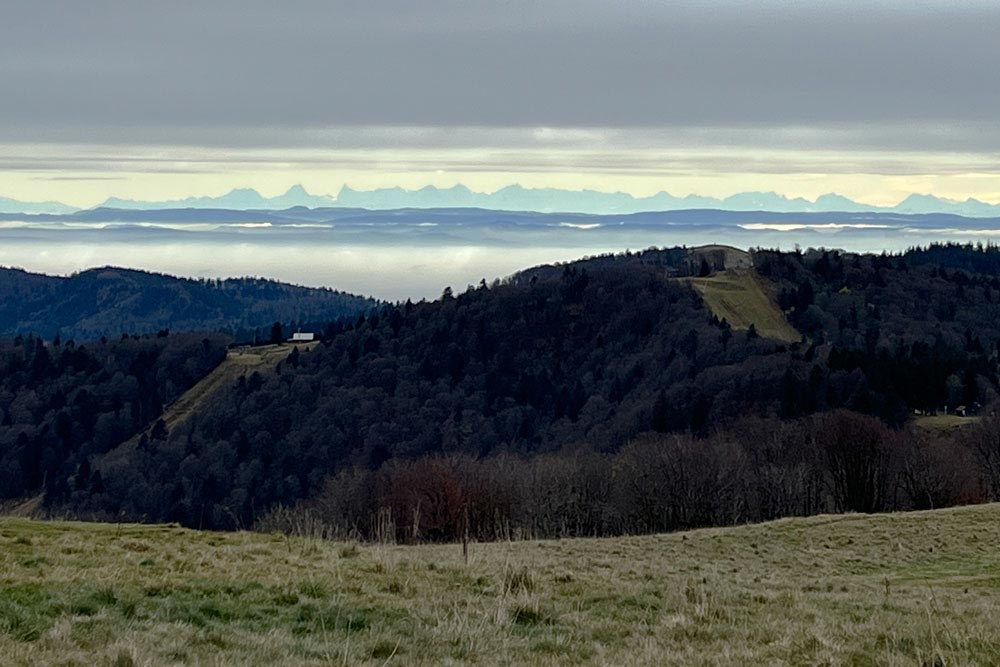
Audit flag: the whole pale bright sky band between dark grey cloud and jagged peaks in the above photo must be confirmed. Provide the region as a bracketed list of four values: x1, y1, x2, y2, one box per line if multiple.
[0, 145, 1000, 208]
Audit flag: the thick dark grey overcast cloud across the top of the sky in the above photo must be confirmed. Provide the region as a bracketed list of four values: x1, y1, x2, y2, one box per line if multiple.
[0, 0, 1000, 145]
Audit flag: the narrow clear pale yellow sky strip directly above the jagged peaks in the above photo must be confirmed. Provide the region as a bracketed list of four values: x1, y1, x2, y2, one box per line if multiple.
[9, 170, 1000, 208]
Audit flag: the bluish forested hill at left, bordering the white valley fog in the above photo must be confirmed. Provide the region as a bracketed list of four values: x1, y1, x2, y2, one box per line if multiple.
[0, 267, 375, 342]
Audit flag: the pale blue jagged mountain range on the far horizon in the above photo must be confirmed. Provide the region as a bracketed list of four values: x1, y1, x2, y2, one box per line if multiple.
[0, 184, 1000, 218]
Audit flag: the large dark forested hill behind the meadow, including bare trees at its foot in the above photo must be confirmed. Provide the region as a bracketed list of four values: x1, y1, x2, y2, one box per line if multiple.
[9, 247, 1000, 538]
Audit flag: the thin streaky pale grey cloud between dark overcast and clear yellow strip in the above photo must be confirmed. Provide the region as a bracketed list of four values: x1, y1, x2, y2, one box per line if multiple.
[7, 136, 1000, 176]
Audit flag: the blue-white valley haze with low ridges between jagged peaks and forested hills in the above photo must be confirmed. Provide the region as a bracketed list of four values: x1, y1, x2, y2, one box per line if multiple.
[0, 201, 1000, 301]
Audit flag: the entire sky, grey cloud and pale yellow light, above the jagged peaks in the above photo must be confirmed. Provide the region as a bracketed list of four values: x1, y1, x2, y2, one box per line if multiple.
[0, 0, 1000, 206]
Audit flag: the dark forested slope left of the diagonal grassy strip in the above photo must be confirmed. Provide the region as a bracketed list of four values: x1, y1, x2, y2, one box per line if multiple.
[0, 334, 229, 499]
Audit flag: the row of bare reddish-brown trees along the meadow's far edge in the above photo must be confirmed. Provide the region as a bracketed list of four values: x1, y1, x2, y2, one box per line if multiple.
[258, 410, 1000, 542]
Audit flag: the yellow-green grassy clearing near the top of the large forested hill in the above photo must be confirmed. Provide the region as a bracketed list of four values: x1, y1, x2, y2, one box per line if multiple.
[683, 269, 802, 343]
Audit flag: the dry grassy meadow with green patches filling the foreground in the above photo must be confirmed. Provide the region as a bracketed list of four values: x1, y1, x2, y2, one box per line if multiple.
[0, 505, 1000, 667]
